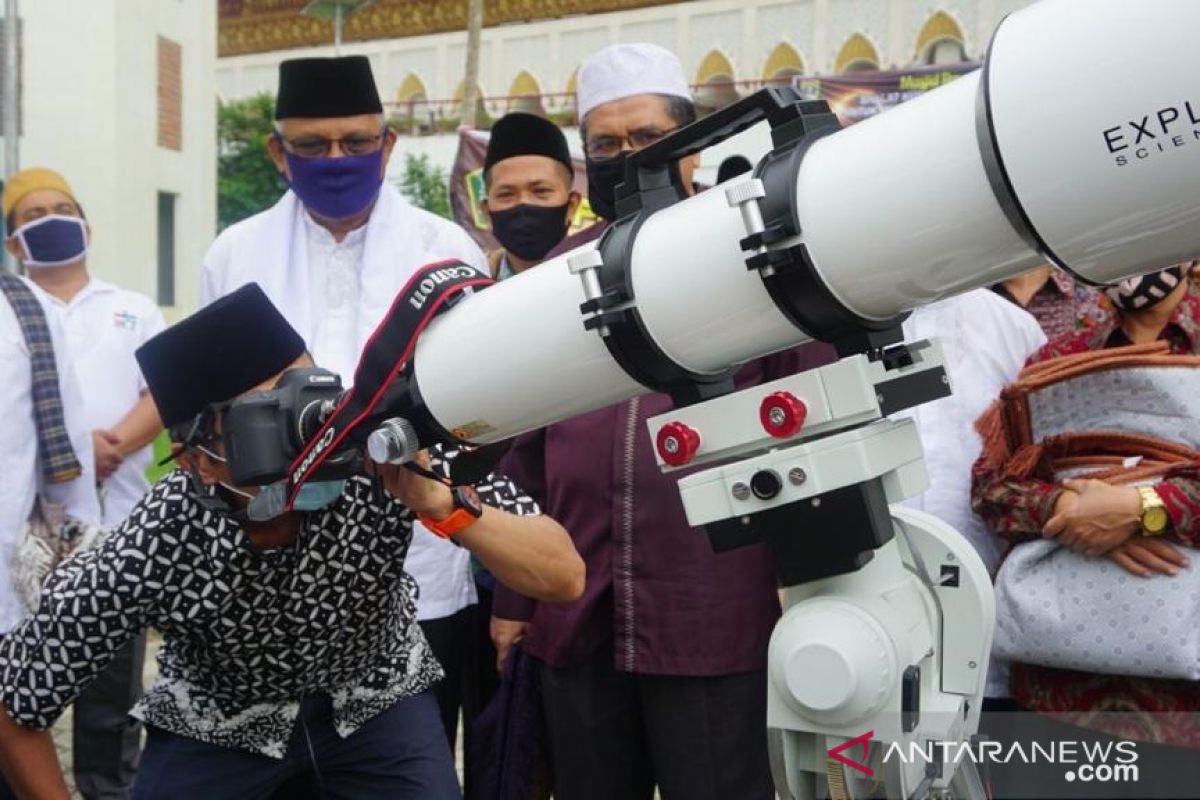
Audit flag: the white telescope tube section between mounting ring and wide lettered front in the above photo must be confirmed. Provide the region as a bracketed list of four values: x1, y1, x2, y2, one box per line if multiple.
[796, 72, 1045, 319]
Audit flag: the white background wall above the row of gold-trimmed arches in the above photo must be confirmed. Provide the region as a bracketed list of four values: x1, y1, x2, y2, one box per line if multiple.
[217, 0, 1031, 102]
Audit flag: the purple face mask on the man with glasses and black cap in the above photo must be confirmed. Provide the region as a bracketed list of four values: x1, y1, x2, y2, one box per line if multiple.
[283, 149, 383, 219]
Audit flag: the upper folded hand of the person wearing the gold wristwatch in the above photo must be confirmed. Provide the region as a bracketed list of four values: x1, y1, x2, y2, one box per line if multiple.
[1042, 479, 1141, 558]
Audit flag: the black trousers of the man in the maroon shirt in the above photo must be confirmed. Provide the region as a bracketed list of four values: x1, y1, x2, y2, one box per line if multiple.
[541, 642, 775, 800]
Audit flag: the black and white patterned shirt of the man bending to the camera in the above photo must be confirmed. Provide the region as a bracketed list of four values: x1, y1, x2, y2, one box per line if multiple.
[0, 471, 538, 758]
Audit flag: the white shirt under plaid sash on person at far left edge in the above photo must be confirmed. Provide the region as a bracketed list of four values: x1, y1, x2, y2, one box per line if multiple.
[0, 278, 100, 633]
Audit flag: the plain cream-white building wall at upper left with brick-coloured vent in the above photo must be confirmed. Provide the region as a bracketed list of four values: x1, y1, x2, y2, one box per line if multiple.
[4, 0, 216, 318]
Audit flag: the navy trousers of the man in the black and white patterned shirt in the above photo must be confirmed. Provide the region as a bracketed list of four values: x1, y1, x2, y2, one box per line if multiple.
[133, 692, 462, 800]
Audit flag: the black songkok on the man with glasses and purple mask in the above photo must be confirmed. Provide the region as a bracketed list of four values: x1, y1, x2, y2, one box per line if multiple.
[275, 55, 383, 120]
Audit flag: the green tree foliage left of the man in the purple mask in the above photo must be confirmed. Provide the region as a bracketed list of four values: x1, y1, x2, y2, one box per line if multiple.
[217, 92, 287, 228]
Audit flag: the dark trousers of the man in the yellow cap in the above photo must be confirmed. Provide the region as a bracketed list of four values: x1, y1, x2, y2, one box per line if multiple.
[71, 632, 146, 800]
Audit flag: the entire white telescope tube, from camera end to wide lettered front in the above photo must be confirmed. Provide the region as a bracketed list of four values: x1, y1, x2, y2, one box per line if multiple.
[415, 0, 1200, 444]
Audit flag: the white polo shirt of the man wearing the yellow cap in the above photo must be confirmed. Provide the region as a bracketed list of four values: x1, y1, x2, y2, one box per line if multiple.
[43, 277, 167, 527]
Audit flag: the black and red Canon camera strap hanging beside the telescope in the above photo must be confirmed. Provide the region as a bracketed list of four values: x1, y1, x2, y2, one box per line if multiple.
[284, 260, 493, 511]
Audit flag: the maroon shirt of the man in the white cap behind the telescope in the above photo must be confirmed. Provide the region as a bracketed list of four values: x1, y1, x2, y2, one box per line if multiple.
[493, 217, 833, 675]
